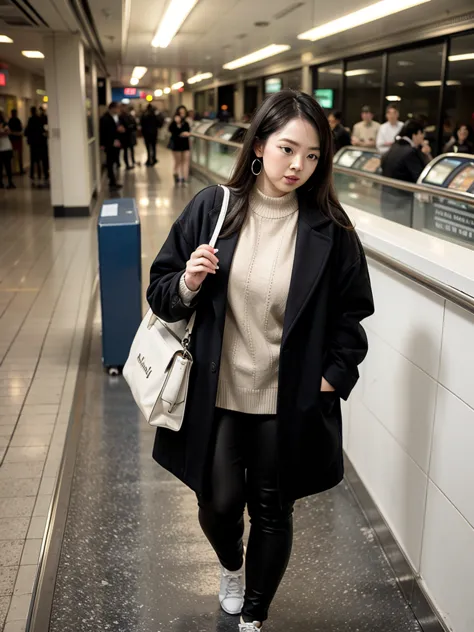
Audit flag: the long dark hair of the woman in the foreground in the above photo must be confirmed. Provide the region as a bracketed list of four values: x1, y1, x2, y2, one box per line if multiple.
[222, 90, 353, 237]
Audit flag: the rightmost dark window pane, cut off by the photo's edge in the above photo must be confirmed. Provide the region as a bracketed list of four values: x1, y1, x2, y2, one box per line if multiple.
[443, 35, 474, 153]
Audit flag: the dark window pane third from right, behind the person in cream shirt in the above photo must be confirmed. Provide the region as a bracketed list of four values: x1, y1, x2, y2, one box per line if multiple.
[344, 56, 384, 129]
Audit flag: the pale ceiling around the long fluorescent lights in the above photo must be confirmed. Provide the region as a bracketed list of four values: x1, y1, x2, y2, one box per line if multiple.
[0, 0, 473, 88]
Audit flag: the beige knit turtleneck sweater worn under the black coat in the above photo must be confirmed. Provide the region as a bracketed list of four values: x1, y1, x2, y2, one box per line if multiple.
[180, 187, 298, 415]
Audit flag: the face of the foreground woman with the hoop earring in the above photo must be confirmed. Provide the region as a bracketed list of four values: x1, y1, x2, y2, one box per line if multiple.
[254, 118, 321, 197]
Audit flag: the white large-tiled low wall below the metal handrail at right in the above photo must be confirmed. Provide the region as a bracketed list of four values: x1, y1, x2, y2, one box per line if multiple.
[343, 263, 474, 632]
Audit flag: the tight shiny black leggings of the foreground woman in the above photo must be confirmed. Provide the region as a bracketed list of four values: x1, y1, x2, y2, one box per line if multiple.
[198, 409, 294, 621]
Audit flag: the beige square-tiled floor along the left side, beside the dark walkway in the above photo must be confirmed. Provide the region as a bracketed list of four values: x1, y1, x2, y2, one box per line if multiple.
[0, 178, 96, 632]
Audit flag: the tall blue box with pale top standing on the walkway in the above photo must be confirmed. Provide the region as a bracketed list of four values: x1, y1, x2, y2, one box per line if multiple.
[98, 198, 142, 375]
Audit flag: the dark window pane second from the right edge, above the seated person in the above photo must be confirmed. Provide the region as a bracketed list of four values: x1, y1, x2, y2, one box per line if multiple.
[385, 44, 443, 151]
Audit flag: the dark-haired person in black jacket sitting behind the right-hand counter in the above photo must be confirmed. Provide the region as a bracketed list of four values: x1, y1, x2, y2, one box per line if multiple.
[381, 119, 431, 226]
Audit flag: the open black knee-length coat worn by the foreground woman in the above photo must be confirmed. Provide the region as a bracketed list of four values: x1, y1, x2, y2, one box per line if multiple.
[147, 186, 373, 500]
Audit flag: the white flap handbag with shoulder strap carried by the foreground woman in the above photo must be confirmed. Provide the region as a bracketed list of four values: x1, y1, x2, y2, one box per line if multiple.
[123, 185, 230, 431]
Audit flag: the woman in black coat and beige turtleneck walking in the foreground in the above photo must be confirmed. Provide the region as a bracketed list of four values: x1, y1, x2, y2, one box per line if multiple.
[147, 90, 373, 632]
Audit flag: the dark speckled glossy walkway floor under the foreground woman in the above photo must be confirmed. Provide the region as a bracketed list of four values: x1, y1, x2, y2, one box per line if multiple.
[45, 151, 420, 632]
